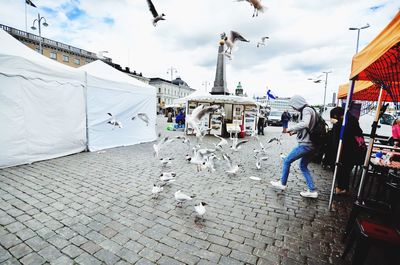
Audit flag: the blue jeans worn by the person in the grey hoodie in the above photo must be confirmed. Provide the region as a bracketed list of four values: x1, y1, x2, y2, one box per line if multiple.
[281, 145, 315, 191]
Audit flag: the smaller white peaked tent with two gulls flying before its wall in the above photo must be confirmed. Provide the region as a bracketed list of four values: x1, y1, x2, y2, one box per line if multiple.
[80, 60, 157, 151]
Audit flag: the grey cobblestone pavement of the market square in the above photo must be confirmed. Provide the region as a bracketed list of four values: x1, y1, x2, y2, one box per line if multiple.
[0, 118, 356, 265]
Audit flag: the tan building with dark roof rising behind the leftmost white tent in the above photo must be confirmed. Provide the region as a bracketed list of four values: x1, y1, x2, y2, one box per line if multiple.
[0, 24, 99, 67]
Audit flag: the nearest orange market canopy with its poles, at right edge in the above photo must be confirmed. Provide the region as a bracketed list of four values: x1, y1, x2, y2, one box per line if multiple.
[329, 12, 400, 209]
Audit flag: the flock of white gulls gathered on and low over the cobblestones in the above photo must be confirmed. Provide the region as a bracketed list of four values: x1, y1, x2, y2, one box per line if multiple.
[151, 105, 284, 223]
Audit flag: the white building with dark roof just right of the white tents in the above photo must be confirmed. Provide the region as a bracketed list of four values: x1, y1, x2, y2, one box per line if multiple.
[149, 77, 196, 111]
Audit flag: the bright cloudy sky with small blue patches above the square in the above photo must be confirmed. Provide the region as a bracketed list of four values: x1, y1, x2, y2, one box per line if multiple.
[0, 0, 400, 103]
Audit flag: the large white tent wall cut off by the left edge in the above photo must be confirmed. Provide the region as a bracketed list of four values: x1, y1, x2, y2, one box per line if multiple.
[0, 30, 86, 168]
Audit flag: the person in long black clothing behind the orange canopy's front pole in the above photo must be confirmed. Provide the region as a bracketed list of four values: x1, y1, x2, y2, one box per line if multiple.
[329, 107, 365, 194]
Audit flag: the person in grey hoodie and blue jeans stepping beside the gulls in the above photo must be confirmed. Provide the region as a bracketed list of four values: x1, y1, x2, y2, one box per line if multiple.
[270, 95, 318, 198]
